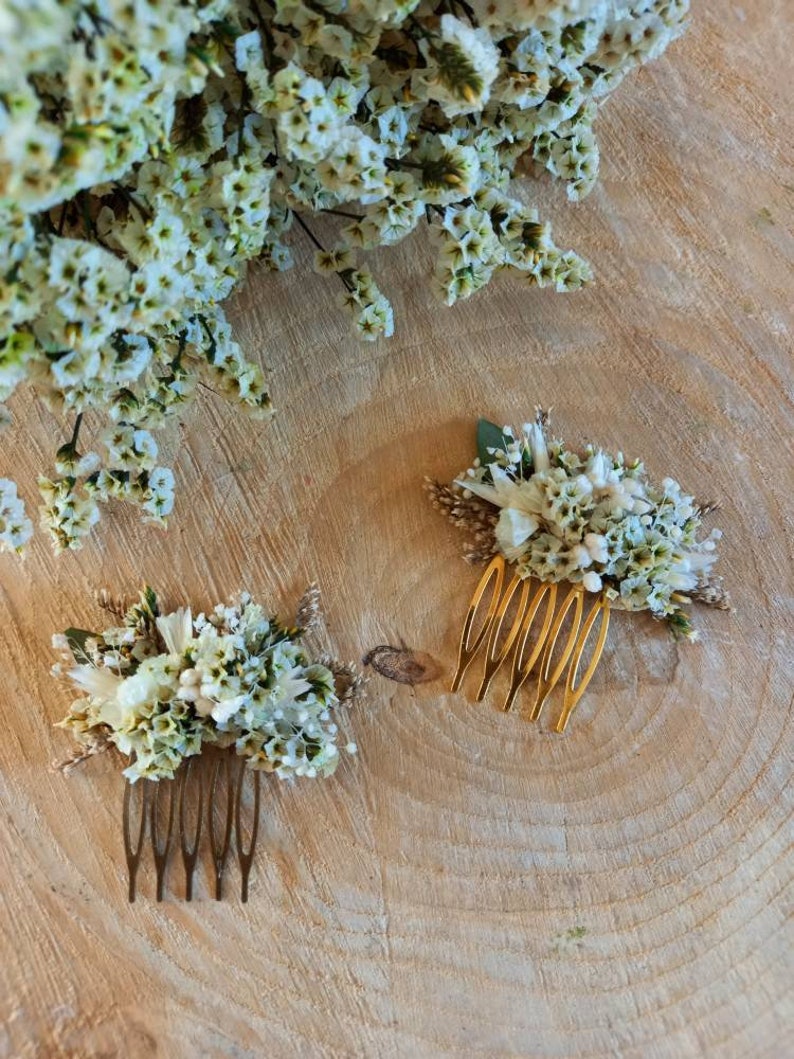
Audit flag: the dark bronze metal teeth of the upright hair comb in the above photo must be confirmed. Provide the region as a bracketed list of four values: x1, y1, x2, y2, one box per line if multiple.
[122, 751, 261, 902]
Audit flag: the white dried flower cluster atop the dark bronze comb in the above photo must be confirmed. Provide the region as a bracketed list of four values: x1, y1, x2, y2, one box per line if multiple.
[53, 589, 355, 780]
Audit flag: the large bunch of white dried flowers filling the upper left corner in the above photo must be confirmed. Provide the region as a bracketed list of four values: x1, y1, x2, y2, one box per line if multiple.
[0, 0, 688, 549]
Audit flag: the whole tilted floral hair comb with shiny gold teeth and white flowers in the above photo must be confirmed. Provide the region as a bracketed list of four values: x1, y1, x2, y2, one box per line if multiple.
[429, 409, 728, 732]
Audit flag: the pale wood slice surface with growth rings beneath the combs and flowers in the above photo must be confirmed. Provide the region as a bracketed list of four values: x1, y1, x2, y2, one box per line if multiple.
[0, 0, 794, 1059]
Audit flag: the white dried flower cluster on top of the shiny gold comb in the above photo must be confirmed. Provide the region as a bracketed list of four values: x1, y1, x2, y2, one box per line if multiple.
[455, 414, 722, 639]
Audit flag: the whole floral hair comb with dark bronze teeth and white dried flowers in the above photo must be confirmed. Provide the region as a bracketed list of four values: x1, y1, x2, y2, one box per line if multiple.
[53, 587, 361, 900]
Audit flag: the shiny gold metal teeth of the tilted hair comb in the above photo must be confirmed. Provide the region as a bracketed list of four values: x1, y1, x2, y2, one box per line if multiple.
[451, 555, 610, 732]
